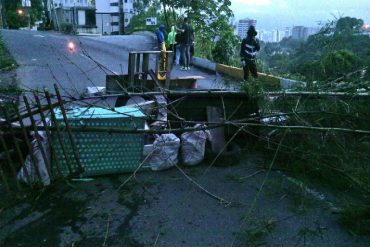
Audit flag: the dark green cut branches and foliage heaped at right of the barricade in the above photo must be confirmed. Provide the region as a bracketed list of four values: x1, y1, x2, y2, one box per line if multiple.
[251, 89, 370, 235]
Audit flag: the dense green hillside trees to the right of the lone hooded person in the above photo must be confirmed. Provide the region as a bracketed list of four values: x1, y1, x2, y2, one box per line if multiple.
[260, 17, 370, 84]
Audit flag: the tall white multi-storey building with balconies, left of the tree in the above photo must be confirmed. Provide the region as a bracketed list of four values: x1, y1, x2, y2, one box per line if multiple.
[96, 0, 135, 34]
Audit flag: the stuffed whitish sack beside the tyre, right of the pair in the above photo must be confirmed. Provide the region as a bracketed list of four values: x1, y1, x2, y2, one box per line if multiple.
[181, 124, 210, 166]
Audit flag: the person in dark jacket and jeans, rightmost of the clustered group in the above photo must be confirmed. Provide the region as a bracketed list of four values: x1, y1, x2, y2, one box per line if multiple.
[179, 17, 194, 70]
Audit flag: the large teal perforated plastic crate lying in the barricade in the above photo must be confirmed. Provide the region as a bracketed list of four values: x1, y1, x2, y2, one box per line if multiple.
[52, 107, 145, 176]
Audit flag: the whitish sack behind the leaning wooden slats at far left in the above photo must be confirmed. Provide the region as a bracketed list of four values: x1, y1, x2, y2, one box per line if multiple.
[17, 127, 50, 186]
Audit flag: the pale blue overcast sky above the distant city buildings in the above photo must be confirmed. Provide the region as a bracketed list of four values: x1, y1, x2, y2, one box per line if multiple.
[231, 0, 370, 29]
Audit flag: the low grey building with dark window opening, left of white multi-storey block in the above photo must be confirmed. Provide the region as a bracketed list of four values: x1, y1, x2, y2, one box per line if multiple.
[48, 0, 97, 34]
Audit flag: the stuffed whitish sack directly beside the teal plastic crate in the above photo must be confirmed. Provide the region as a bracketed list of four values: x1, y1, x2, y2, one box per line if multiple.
[145, 134, 180, 171]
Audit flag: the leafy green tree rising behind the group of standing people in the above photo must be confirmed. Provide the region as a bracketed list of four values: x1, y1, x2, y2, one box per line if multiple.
[128, 0, 239, 63]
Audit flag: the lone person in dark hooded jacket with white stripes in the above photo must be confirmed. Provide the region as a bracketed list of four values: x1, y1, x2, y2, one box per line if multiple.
[240, 26, 260, 80]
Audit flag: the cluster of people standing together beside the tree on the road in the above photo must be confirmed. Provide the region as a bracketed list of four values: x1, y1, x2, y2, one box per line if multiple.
[156, 17, 194, 70]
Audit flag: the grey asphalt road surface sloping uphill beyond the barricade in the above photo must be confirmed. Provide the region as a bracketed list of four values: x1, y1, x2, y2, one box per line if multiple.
[2, 30, 224, 99]
